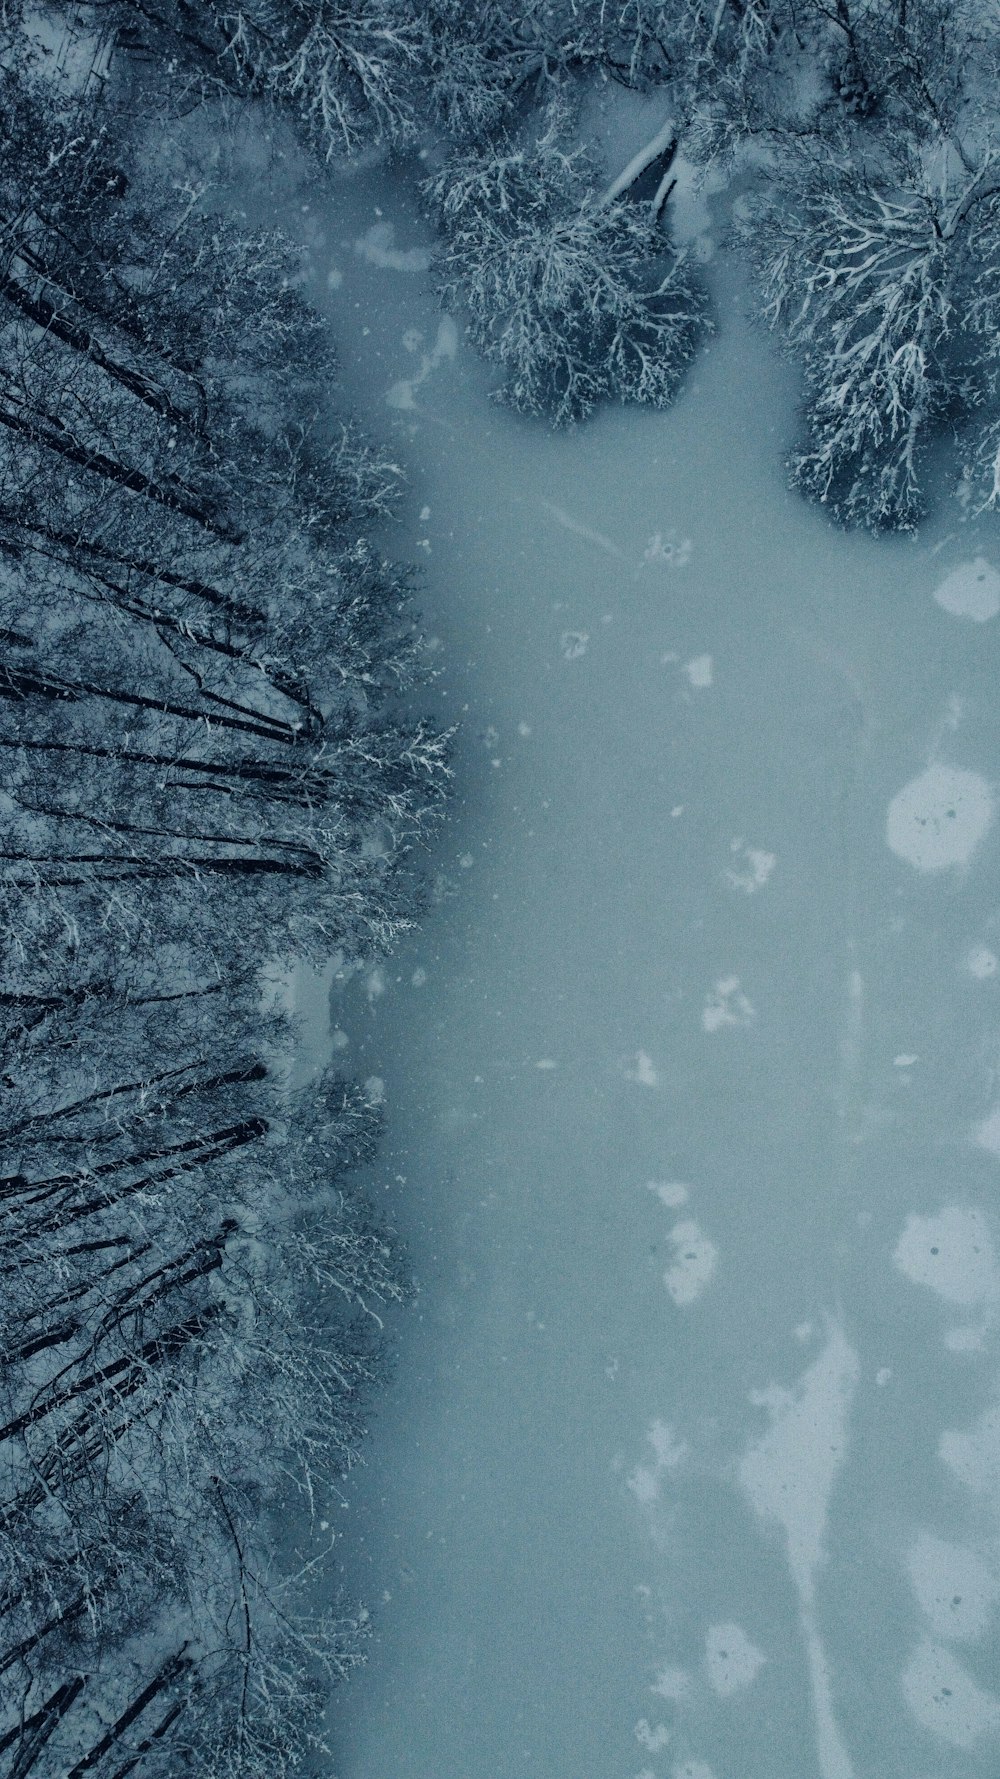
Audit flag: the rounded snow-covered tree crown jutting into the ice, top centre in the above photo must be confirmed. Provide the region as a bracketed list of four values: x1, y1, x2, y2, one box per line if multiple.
[423, 107, 706, 425]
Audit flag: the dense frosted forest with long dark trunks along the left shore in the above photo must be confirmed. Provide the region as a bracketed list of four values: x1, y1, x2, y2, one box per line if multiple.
[0, 21, 448, 1779]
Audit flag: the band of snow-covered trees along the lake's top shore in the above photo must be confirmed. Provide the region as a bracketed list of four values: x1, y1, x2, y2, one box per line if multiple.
[46, 0, 1000, 528]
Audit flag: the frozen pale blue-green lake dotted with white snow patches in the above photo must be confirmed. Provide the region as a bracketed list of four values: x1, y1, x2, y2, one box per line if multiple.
[272, 142, 1000, 1779]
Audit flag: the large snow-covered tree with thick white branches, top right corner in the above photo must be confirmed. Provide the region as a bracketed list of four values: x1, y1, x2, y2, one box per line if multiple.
[740, 0, 1000, 530]
